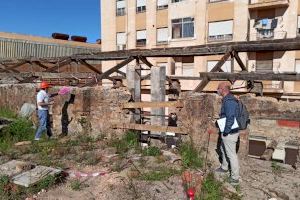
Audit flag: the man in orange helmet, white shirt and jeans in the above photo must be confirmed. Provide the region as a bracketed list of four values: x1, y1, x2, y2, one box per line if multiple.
[34, 81, 53, 140]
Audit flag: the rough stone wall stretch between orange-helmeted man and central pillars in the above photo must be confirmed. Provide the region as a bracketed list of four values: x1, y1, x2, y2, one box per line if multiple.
[52, 87, 131, 136]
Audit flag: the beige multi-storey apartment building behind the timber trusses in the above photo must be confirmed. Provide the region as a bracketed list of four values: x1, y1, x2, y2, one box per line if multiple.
[101, 0, 300, 93]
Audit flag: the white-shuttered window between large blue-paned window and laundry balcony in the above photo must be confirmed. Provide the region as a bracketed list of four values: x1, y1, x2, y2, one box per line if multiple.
[208, 20, 233, 41]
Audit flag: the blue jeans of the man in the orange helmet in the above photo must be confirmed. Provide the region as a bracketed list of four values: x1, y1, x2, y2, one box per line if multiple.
[35, 110, 52, 138]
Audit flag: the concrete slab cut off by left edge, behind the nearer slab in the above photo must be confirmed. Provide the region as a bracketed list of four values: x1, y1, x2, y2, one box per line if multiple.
[0, 160, 31, 177]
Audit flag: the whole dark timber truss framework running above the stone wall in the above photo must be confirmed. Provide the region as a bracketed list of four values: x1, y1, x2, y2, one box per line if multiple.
[0, 38, 300, 92]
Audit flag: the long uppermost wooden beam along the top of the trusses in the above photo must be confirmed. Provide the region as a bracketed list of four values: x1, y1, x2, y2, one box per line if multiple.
[0, 38, 300, 63]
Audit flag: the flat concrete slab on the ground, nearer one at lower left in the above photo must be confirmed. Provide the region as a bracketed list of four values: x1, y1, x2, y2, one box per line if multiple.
[12, 166, 62, 187]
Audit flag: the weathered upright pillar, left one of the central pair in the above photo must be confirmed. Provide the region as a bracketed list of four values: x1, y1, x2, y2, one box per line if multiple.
[126, 65, 141, 123]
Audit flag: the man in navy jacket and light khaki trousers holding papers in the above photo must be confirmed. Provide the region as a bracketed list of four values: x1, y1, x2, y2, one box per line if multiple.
[216, 82, 239, 185]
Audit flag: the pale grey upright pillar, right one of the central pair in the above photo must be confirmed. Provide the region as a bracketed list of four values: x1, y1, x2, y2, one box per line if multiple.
[151, 66, 166, 131]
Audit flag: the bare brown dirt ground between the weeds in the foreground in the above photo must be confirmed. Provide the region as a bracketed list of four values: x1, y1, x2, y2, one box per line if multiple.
[37, 145, 300, 200]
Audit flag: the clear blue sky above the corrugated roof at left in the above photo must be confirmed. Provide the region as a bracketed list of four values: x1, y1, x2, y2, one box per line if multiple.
[0, 0, 100, 43]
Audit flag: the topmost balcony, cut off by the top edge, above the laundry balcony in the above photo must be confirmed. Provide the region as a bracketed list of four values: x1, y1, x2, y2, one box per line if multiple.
[249, 0, 289, 10]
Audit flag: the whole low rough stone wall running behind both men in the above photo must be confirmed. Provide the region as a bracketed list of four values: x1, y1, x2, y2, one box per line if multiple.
[0, 84, 300, 146]
